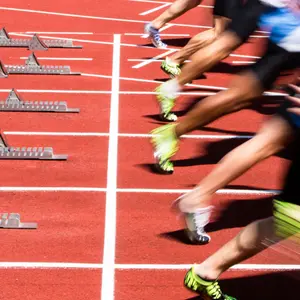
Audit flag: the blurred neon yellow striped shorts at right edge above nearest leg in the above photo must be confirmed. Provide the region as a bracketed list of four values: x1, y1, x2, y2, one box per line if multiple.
[273, 199, 300, 243]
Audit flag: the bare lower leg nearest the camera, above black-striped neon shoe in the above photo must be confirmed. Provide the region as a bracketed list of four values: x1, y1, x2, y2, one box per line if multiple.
[195, 217, 274, 280]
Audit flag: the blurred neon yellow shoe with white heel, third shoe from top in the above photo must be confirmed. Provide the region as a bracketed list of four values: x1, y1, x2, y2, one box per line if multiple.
[155, 84, 177, 122]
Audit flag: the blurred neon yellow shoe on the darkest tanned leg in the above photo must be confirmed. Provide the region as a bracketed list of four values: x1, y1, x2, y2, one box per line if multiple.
[151, 124, 179, 174]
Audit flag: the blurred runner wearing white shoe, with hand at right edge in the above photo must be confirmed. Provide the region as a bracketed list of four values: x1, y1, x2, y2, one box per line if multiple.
[176, 86, 300, 244]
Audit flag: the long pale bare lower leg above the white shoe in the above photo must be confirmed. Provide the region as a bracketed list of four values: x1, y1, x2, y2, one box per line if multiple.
[179, 116, 294, 212]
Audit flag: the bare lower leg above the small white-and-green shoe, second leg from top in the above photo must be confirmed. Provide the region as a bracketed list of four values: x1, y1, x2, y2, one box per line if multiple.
[170, 16, 230, 65]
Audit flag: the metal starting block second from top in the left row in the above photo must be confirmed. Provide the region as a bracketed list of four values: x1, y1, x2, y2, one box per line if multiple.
[0, 53, 81, 78]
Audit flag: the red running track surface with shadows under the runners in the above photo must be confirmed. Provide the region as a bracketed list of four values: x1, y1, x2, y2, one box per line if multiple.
[0, 0, 298, 300]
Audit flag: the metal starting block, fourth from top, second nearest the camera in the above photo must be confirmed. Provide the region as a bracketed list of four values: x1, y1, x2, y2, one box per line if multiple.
[0, 132, 68, 160]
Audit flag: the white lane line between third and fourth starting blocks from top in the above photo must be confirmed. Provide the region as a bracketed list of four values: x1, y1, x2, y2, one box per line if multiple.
[3, 131, 253, 140]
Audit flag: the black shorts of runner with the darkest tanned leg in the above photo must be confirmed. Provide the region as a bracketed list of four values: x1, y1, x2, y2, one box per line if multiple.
[249, 41, 300, 89]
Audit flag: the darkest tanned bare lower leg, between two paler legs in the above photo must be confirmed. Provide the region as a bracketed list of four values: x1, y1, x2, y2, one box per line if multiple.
[175, 71, 263, 137]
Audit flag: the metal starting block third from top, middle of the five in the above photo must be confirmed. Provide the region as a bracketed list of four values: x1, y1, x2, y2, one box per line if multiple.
[0, 89, 80, 113]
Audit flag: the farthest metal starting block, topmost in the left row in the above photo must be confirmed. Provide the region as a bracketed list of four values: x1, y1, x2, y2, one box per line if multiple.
[0, 28, 82, 51]
